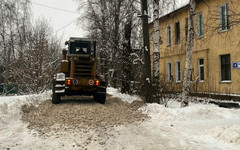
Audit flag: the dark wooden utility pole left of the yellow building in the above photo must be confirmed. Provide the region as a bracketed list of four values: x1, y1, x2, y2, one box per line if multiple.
[141, 0, 153, 103]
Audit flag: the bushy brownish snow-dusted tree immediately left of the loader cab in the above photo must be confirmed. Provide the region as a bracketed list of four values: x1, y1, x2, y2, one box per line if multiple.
[13, 19, 61, 93]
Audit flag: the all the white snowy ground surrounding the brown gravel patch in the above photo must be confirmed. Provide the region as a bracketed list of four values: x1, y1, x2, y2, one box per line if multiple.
[0, 88, 240, 150]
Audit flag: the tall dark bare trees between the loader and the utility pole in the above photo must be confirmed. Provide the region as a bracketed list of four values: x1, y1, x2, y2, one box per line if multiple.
[77, 0, 141, 91]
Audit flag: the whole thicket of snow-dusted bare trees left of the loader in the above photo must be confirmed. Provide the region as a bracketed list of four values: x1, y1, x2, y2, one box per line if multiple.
[0, 0, 60, 94]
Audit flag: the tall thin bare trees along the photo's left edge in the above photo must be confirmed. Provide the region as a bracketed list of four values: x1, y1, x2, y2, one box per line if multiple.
[0, 0, 30, 94]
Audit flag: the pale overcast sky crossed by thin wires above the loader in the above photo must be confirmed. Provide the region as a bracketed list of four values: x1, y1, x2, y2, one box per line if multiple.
[31, 0, 85, 44]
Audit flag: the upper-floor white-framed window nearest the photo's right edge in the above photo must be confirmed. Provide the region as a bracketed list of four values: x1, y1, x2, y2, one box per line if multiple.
[218, 2, 230, 32]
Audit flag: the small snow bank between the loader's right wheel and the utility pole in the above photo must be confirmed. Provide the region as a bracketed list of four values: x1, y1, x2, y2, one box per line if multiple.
[107, 87, 141, 103]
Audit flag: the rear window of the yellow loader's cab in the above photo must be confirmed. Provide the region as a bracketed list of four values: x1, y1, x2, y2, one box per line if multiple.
[70, 41, 91, 54]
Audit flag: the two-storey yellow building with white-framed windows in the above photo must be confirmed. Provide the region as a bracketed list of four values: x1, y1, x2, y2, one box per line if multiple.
[150, 0, 240, 94]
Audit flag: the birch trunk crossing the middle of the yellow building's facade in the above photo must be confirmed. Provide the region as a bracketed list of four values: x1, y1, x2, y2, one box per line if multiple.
[181, 0, 195, 107]
